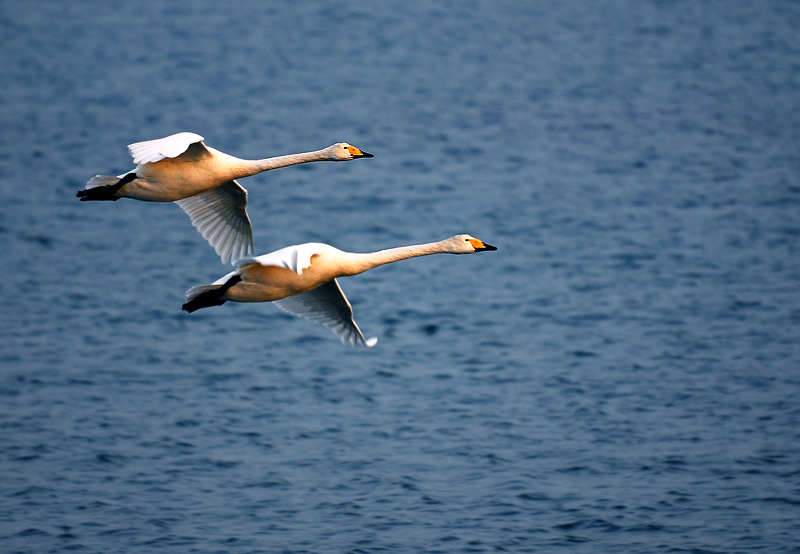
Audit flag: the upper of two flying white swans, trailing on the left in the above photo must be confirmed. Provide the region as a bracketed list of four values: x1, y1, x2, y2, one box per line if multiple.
[78, 132, 373, 263]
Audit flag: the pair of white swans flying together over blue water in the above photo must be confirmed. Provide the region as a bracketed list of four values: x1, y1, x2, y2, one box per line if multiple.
[78, 133, 497, 347]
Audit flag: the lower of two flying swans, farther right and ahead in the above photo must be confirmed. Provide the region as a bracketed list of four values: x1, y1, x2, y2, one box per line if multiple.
[183, 235, 497, 347]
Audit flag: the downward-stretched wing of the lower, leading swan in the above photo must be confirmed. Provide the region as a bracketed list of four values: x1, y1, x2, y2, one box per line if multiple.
[273, 279, 378, 347]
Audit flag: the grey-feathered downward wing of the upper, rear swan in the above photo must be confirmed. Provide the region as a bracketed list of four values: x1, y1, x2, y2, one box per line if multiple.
[175, 181, 253, 263]
